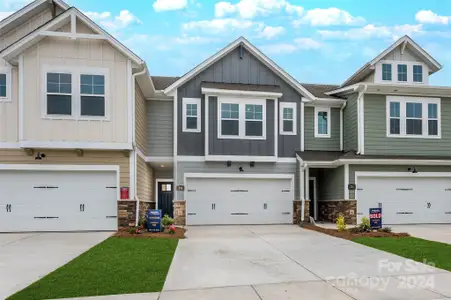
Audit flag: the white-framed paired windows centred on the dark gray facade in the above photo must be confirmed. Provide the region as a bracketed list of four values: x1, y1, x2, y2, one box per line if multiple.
[218, 99, 266, 139]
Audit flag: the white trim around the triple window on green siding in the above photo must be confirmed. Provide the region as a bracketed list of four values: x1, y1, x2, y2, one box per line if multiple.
[385, 96, 442, 139]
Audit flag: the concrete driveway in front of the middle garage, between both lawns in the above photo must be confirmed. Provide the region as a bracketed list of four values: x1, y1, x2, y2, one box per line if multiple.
[159, 225, 451, 300]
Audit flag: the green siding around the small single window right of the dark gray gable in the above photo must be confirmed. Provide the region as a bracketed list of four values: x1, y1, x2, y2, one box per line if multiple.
[304, 107, 340, 151]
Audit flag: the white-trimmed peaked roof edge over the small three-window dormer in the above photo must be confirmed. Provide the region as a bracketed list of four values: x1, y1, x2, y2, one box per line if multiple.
[340, 35, 442, 87]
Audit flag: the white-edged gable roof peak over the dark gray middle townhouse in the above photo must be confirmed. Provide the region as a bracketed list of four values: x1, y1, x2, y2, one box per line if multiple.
[164, 37, 315, 99]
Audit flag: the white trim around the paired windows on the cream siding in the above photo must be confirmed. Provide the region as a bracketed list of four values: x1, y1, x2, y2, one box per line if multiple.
[41, 66, 110, 121]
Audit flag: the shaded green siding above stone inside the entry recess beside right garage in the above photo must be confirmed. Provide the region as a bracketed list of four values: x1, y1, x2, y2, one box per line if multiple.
[317, 166, 344, 200]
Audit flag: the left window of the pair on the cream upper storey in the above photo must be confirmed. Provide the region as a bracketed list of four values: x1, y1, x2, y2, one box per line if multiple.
[46, 73, 73, 116]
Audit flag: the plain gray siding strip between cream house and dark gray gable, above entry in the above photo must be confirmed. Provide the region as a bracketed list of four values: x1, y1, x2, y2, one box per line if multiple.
[146, 101, 174, 156]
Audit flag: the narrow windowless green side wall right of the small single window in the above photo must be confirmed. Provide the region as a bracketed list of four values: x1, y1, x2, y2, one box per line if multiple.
[343, 93, 359, 151]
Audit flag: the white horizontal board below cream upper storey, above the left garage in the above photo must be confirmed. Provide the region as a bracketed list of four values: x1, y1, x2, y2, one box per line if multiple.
[19, 141, 133, 150]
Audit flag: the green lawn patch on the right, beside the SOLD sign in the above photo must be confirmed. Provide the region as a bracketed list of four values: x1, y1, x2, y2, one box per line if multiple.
[353, 237, 451, 271]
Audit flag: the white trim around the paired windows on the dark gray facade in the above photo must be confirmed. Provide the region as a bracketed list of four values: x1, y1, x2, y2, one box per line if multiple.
[218, 97, 266, 140]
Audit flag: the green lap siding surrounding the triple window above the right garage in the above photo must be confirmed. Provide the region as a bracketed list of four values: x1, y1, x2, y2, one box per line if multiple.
[364, 94, 451, 156]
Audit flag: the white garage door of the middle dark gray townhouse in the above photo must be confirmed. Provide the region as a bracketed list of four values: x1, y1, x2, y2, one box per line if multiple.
[185, 178, 294, 225]
